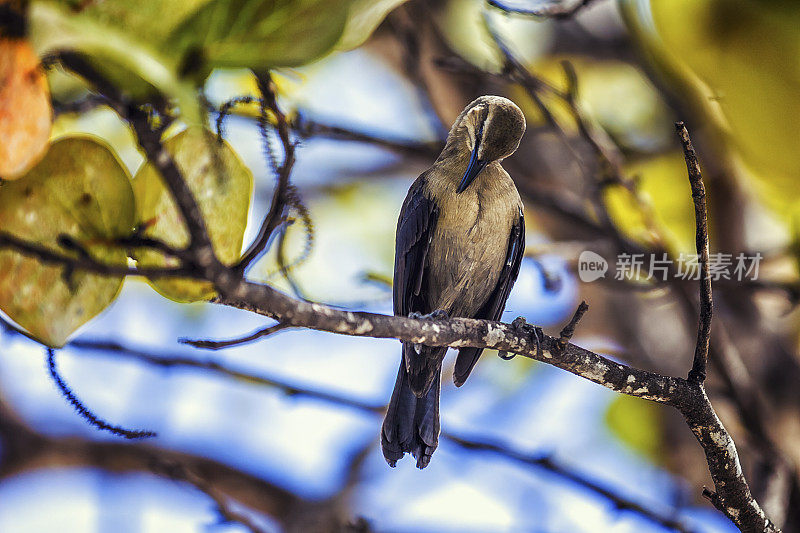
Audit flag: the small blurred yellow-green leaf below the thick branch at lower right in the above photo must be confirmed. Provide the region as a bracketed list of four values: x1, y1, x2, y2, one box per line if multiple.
[606, 395, 663, 464]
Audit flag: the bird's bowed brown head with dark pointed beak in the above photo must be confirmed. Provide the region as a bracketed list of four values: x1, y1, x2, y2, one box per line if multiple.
[447, 96, 525, 193]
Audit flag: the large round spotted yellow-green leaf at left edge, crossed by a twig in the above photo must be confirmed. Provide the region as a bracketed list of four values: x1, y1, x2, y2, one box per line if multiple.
[0, 136, 135, 347]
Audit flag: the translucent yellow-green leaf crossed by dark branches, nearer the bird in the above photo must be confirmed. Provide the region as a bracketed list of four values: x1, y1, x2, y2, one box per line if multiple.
[133, 128, 253, 302]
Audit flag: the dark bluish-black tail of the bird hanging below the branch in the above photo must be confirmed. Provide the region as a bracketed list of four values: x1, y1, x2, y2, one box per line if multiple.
[381, 357, 441, 468]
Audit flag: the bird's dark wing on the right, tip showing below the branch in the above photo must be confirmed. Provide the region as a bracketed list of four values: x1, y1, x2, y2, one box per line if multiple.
[453, 209, 525, 387]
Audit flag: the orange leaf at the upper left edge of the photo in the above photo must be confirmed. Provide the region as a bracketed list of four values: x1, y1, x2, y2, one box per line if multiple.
[0, 39, 53, 180]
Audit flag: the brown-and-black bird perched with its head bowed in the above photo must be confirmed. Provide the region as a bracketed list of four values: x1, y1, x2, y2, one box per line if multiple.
[381, 96, 525, 469]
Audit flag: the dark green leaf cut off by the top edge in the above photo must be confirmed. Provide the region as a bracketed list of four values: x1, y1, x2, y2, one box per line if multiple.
[168, 0, 352, 70]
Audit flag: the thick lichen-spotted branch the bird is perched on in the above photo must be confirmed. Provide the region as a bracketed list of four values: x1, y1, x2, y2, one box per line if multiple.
[215, 281, 778, 532]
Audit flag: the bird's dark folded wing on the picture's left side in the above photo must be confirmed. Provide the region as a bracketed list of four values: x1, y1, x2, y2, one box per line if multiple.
[393, 174, 439, 316]
